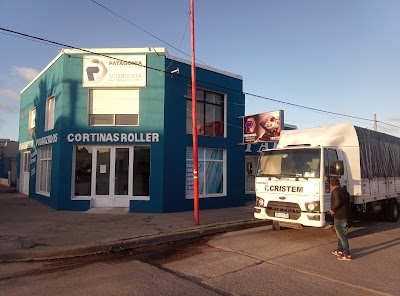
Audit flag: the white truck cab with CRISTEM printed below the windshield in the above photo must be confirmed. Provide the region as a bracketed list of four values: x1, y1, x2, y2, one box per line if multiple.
[254, 145, 347, 229]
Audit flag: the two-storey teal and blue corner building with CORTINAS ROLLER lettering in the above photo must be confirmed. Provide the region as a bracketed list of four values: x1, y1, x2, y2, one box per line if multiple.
[18, 48, 245, 213]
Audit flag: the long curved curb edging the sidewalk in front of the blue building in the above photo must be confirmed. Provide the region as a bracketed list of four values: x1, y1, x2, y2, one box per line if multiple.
[0, 220, 271, 263]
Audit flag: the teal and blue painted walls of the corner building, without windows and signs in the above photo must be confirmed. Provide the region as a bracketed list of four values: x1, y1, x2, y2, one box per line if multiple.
[18, 53, 245, 213]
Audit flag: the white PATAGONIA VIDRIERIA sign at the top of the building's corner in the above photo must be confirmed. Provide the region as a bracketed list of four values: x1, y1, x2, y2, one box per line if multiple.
[82, 55, 146, 87]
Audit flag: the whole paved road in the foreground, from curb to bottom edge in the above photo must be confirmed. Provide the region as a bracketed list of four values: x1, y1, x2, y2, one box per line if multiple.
[0, 221, 400, 296]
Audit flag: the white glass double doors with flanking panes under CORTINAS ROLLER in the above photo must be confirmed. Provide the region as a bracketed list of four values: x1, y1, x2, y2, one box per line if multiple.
[72, 145, 150, 200]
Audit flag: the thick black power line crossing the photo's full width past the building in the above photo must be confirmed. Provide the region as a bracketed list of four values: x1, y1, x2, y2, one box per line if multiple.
[0, 27, 400, 133]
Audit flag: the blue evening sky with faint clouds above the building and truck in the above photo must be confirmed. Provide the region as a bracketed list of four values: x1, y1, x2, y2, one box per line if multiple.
[0, 0, 400, 140]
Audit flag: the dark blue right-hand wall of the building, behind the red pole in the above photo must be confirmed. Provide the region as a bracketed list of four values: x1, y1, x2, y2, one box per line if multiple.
[164, 60, 245, 212]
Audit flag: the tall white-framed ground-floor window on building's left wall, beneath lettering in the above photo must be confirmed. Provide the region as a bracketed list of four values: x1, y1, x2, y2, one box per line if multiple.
[36, 147, 52, 195]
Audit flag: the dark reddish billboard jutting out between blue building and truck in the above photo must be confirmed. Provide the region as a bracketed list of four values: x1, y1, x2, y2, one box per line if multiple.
[243, 110, 284, 144]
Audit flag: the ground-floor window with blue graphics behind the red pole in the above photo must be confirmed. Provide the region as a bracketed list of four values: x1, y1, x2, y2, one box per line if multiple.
[186, 147, 226, 198]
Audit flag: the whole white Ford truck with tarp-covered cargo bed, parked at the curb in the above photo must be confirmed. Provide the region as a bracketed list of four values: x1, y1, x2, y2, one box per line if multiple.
[254, 123, 400, 230]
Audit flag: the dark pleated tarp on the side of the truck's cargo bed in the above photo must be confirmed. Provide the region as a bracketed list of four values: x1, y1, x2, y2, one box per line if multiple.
[355, 126, 400, 179]
